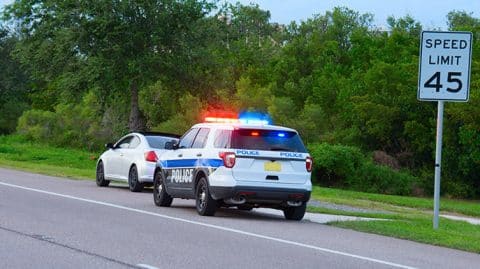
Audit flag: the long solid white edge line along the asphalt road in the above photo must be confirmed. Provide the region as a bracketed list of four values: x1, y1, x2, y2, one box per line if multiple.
[0, 182, 415, 269]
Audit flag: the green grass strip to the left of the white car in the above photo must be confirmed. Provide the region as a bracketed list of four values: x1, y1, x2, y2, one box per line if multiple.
[0, 135, 99, 179]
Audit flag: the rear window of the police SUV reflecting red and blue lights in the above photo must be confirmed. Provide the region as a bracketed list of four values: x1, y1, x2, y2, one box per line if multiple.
[232, 129, 307, 152]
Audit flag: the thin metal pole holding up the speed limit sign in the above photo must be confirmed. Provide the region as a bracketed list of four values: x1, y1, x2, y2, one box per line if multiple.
[433, 101, 444, 230]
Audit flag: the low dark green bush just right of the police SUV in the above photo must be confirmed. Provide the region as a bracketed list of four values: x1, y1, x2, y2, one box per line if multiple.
[308, 143, 418, 195]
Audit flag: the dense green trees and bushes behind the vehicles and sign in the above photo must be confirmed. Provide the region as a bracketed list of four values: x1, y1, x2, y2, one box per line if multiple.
[0, 0, 480, 197]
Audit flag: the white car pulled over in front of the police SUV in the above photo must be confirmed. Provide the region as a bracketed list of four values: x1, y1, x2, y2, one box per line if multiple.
[96, 132, 179, 192]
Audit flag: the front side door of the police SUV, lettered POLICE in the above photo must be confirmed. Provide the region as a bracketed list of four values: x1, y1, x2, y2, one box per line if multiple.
[164, 128, 199, 193]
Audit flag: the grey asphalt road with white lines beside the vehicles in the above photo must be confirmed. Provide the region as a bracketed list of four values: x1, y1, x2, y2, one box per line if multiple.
[0, 168, 480, 269]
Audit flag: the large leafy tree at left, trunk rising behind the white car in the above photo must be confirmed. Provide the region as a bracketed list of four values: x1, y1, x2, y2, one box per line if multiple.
[5, 0, 213, 130]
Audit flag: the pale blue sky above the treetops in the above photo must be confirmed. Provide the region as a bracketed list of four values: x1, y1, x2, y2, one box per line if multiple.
[0, 0, 480, 30]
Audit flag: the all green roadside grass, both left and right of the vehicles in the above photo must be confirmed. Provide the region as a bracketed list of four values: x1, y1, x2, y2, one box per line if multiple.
[0, 135, 480, 253]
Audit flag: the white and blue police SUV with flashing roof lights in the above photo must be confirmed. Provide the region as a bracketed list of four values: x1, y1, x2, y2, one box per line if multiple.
[153, 118, 313, 220]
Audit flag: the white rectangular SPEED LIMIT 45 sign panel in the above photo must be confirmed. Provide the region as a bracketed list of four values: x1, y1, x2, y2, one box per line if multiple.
[417, 31, 472, 102]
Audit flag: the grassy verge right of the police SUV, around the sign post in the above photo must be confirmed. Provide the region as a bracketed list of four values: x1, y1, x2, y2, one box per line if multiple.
[308, 187, 480, 253]
